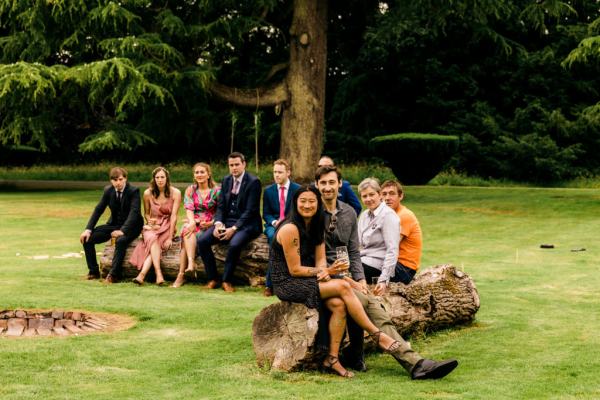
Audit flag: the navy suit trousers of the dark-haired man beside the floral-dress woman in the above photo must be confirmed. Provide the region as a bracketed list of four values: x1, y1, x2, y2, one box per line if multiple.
[196, 226, 255, 283]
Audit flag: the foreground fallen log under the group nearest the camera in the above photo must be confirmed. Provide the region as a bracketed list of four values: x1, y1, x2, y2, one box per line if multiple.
[252, 264, 479, 371]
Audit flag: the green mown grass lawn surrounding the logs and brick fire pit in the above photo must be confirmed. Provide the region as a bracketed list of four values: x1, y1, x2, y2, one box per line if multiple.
[0, 186, 600, 400]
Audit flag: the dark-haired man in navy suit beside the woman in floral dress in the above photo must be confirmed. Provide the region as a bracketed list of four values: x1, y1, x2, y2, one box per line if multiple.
[197, 152, 262, 293]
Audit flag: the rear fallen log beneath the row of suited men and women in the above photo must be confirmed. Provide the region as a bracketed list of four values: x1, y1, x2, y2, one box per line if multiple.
[100, 234, 269, 286]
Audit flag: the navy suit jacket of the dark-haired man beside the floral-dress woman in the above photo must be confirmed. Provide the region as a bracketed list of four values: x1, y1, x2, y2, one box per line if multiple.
[215, 171, 262, 234]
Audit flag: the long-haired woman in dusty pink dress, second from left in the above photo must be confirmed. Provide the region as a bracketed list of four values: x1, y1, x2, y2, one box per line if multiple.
[129, 167, 181, 285]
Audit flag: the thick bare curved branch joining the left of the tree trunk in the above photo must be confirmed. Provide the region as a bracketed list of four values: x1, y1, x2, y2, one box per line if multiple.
[210, 82, 289, 107]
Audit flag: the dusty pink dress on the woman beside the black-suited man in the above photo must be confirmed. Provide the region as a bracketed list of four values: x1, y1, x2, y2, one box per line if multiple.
[129, 197, 173, 269]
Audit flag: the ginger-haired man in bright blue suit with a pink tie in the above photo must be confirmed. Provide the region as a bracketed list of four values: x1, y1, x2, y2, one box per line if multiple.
[263, 158, 300, 296]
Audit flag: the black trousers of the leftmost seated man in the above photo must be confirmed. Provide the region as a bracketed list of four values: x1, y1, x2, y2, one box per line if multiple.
[83, 225, 140, 278]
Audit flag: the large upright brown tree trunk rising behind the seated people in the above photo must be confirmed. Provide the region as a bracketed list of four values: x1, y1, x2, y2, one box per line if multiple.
[280, 0, 327, 183]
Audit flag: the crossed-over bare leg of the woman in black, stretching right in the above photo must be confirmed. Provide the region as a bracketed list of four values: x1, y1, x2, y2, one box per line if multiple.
[319, 279, 395, 350]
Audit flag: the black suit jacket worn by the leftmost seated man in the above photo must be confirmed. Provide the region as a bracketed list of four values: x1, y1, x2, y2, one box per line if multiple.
[86, 183, 144, 235]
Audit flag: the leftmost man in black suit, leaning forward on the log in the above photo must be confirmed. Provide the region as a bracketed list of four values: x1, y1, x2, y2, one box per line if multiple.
[79, 167, 144, 283]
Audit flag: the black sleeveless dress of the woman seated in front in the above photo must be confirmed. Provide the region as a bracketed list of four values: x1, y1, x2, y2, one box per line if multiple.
[269, 222, 321, 309]
